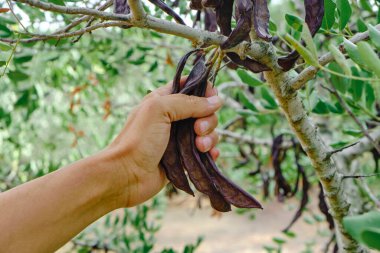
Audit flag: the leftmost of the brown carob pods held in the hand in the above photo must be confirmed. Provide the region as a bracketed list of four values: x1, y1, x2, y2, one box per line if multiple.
[160, 50, 198, 196]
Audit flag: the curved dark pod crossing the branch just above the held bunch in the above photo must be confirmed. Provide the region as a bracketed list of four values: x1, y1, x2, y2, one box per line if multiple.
[220, 0, 253, 49]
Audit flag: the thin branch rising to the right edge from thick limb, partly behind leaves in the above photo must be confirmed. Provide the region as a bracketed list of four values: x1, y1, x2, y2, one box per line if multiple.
[290, 24, 380, 90]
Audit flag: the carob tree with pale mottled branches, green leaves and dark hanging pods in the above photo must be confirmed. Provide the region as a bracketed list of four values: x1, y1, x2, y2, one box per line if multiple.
[0, 0, 380, 252]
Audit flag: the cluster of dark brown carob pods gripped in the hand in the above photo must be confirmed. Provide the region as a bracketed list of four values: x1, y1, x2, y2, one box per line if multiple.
[161, 50, 261, 212]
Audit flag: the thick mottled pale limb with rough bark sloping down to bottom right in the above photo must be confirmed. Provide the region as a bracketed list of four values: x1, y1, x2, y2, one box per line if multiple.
[263, 53, 365, 252]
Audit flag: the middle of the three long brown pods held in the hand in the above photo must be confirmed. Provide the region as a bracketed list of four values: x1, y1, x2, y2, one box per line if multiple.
[176, 58, 231, 212]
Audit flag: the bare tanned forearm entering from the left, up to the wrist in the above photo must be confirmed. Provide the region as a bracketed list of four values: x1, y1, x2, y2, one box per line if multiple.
[0, 149, 125, 252]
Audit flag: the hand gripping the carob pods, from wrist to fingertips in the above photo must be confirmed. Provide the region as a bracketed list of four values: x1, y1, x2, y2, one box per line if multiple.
[105, 78, 222, 207]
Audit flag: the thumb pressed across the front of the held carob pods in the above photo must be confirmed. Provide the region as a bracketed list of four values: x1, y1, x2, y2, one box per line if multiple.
[160, 94, 223, 122]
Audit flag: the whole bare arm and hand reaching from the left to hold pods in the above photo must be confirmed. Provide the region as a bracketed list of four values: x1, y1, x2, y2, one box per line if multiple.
[0, 78, 221, 252]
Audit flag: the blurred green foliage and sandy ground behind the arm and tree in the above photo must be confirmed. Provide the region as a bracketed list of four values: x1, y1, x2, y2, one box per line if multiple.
[0, 0, 380, 253]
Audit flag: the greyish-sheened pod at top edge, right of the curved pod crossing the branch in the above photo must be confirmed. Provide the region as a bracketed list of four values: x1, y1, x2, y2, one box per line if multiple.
[253, 0, 272, 41]
